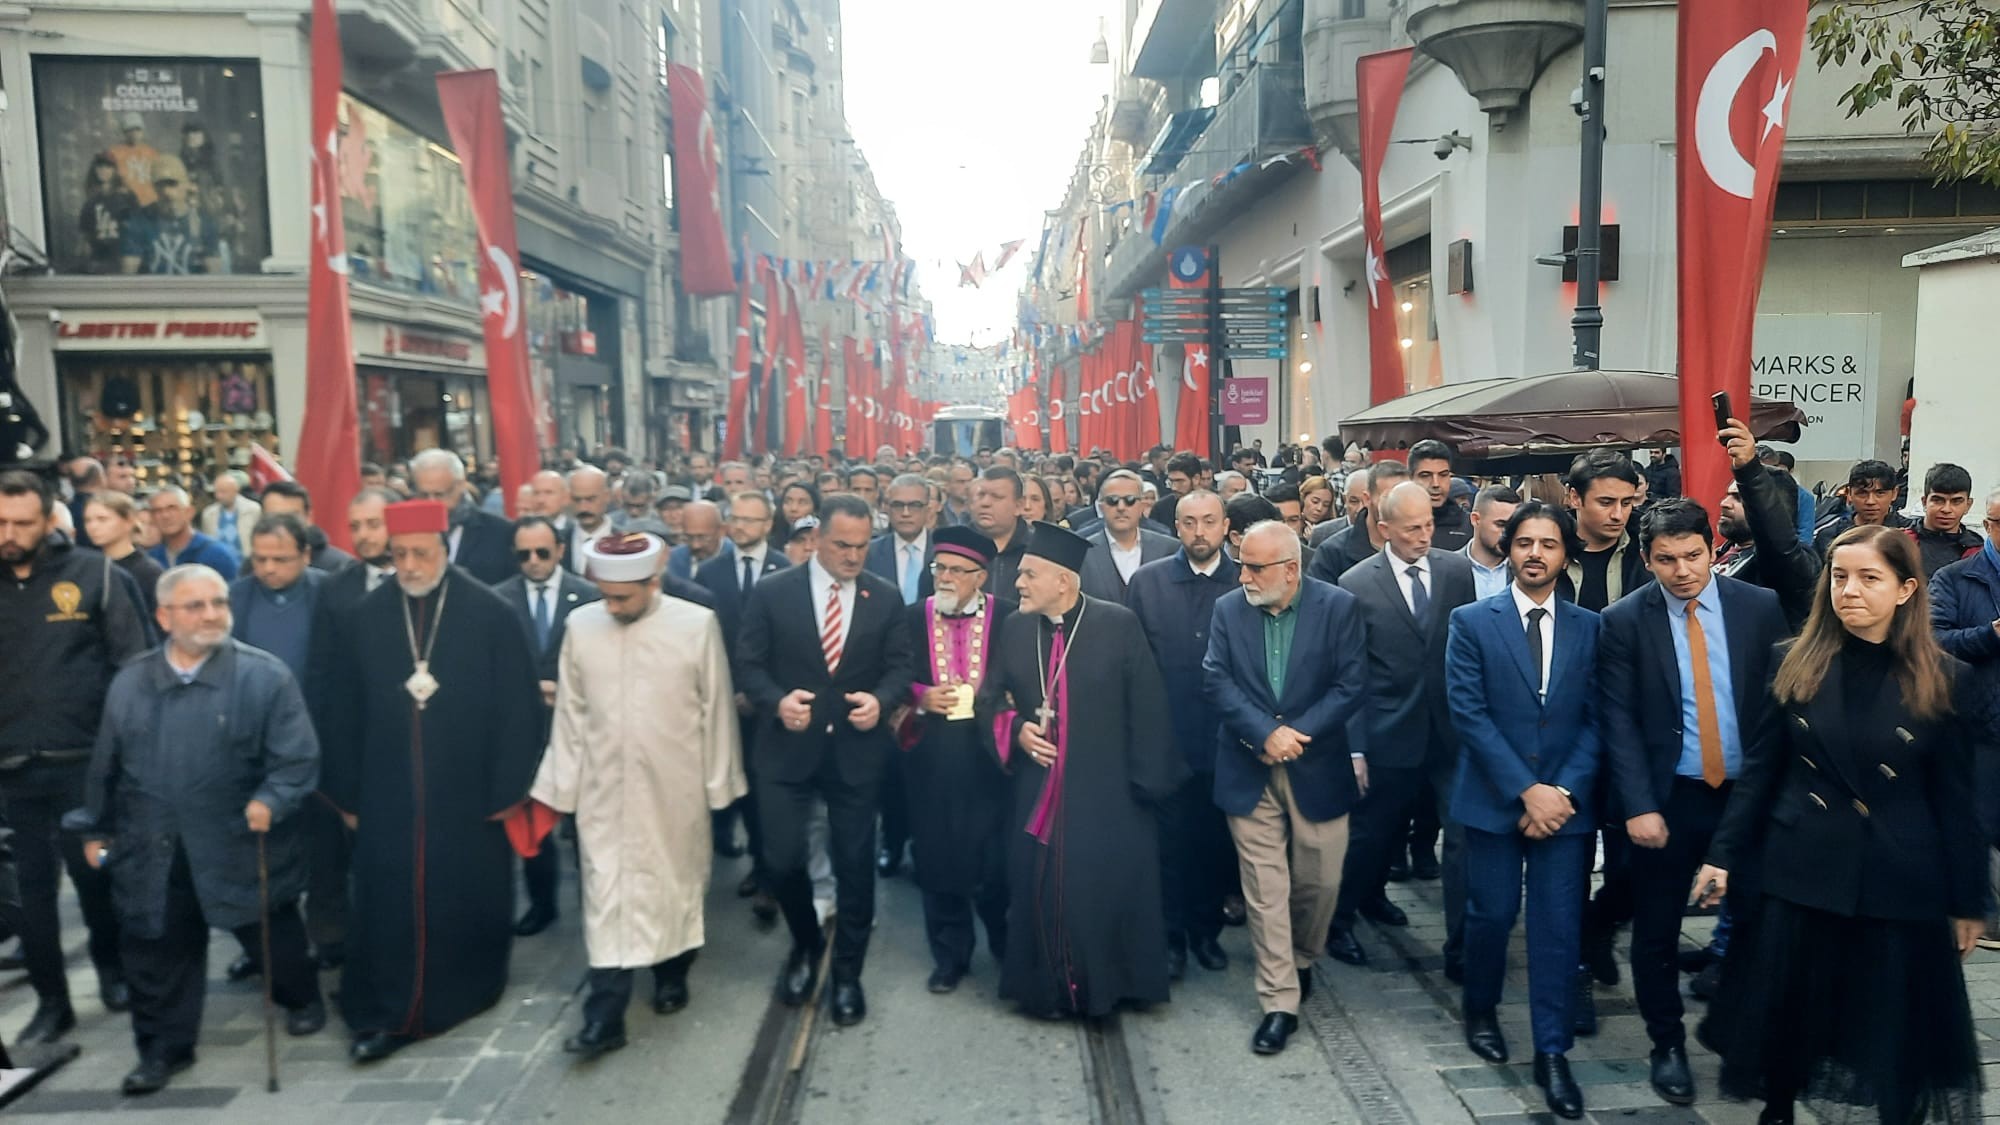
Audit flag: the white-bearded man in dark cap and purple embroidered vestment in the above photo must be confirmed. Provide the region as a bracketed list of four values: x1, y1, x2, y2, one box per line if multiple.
[898, 524, 1014, 993]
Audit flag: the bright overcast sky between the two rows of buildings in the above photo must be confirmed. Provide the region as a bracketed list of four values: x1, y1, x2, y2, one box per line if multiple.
[840, 0, 1118, 344]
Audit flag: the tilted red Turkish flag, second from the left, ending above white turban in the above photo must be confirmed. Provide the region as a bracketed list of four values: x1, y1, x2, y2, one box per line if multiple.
[438, 70, 542, 516]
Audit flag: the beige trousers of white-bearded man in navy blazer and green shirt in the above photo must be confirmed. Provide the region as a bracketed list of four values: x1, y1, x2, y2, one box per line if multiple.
[1230, 765, 1348, 1015]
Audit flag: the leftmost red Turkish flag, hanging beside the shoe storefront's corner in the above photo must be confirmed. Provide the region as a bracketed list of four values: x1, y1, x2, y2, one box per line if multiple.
[294, 0, 362, 550]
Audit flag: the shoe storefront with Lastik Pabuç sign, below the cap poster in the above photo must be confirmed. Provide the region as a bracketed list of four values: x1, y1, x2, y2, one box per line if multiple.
[54, 308, 282, 486]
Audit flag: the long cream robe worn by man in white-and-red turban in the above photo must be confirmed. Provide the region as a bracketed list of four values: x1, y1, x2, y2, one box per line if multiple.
[532, 595, 748, 969]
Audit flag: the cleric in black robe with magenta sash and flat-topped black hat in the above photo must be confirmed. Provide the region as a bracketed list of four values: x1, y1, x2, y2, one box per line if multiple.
[978, 522, 1188, 1017]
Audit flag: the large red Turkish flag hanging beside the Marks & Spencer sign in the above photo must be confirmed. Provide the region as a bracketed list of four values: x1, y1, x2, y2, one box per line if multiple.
[1674, 0, 1808, 512]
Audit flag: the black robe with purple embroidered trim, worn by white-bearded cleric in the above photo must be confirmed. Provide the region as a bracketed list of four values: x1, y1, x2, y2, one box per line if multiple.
[898, 597, 1014, 895]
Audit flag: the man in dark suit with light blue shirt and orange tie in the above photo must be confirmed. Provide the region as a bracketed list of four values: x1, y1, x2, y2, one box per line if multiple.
[1598, 498, 1786, 1105]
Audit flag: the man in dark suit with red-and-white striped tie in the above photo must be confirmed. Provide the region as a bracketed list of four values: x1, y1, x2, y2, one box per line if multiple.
[736, 492, 916, 1027]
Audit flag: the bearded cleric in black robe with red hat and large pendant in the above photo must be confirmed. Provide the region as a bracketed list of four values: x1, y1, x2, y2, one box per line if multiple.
[320, 500, 542, 1063]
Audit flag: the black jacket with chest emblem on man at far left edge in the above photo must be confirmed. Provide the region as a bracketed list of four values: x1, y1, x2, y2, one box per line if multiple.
[0, 532, 152, 767]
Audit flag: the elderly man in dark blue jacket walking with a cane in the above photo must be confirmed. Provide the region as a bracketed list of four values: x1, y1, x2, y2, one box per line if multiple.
[64, 565, 326, 1095]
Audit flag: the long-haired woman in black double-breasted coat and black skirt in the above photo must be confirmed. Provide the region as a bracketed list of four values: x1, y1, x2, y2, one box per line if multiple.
[1696, 526, 1988, 1125]
